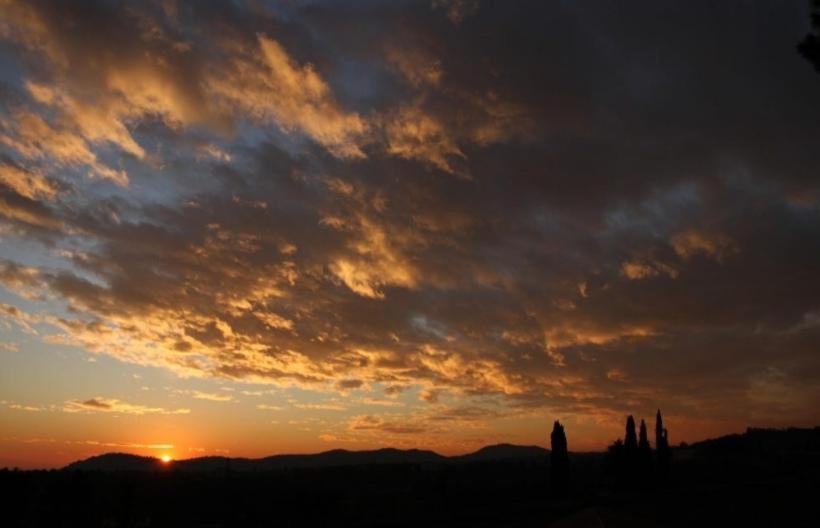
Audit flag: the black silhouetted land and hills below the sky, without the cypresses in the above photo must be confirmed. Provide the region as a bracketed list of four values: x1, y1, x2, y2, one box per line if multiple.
[0, 428, 820, 527]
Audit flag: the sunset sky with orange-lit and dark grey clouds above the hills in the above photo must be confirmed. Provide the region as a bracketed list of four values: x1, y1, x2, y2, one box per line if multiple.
[0, 0, 820, 467]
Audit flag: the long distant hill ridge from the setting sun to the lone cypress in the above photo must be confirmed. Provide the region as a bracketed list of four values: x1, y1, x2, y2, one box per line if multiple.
[65, 444, 549, 472]
